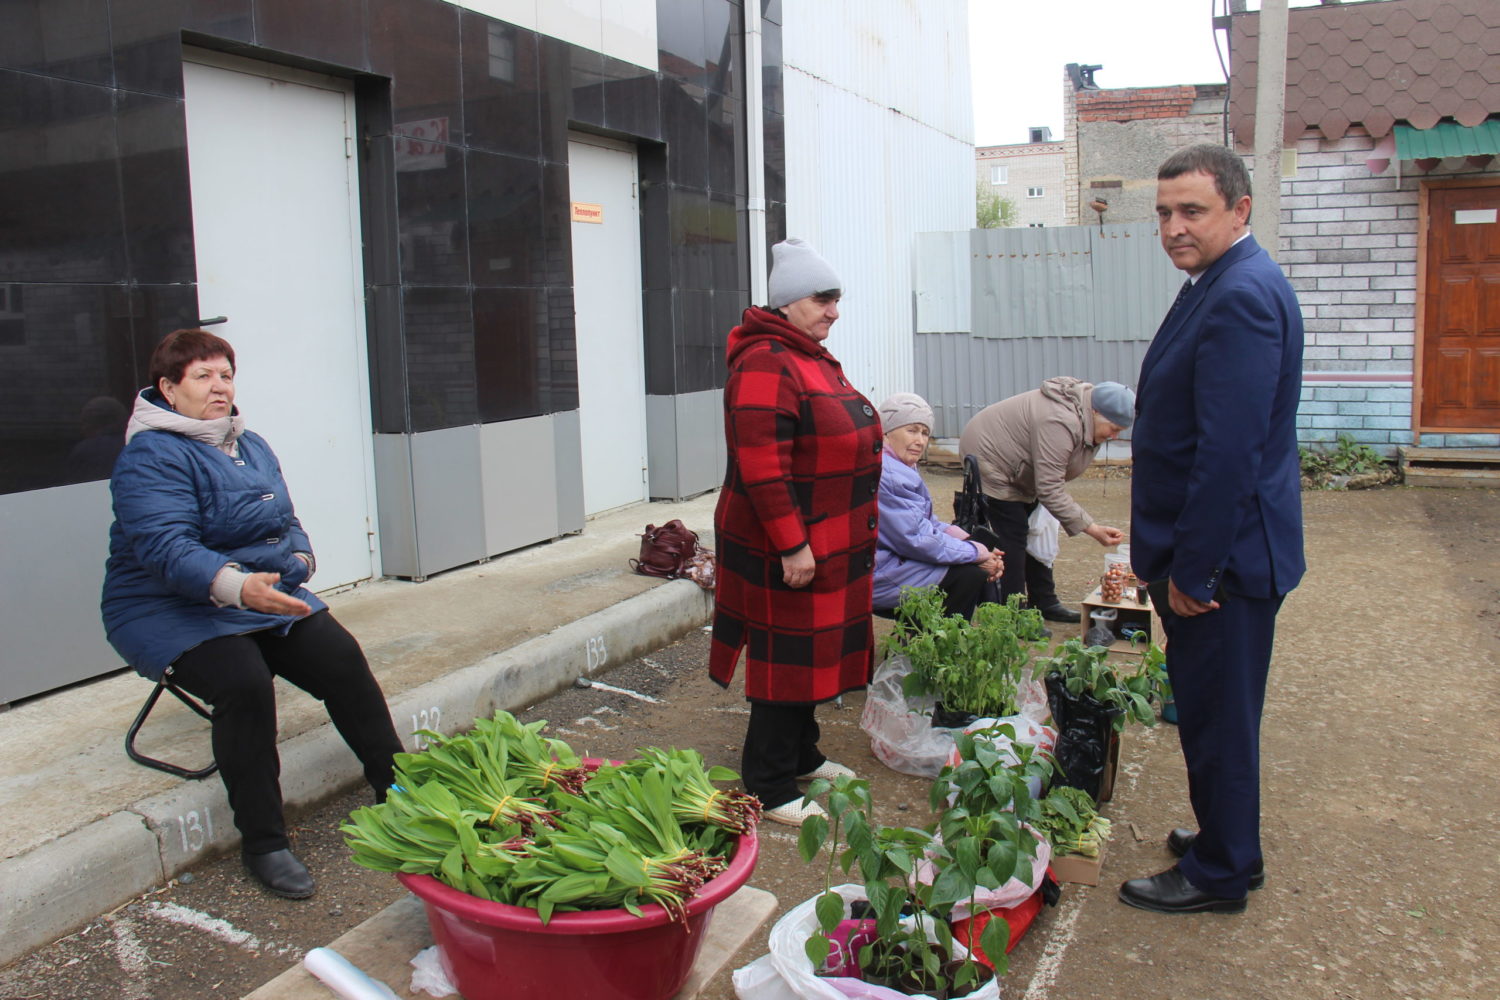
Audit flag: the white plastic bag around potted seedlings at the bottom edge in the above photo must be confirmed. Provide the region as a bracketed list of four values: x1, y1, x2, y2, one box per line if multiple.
[734, 885, 1001, 1000]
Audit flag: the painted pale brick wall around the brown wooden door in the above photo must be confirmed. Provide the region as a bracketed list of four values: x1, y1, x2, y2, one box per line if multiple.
[1278, 126, 1500, 454]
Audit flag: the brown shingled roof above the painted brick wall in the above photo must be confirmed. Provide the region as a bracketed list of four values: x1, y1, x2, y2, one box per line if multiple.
[1230, 0, 1500, 145]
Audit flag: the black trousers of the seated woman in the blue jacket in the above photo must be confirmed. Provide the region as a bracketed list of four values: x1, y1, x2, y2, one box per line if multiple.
[171, 610, 402, 855]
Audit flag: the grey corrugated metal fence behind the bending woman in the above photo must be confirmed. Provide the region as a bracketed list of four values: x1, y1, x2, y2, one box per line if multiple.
[914, 222, 1184, 438]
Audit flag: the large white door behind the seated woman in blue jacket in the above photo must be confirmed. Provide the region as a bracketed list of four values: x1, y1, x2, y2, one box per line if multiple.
[183, 56, 380, 589]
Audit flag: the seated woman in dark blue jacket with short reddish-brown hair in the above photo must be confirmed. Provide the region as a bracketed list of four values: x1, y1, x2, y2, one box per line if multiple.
[102, 330, 402, 900]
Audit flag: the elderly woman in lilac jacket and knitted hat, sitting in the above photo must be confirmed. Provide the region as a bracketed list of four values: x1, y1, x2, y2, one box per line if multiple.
[875, 393, 1005, 618]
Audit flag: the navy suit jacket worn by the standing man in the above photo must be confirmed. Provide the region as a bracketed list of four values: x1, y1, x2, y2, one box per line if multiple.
[1130, 237, 1307, 601]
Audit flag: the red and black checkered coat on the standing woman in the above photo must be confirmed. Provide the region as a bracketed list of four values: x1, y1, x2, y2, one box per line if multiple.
[708, 307, 881, 703]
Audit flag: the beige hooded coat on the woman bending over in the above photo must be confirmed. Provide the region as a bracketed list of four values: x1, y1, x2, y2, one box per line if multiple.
[959, 375, 1100, 535]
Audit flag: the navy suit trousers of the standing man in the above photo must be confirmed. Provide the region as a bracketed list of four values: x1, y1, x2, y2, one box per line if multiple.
[1151, 580, 1283, 898]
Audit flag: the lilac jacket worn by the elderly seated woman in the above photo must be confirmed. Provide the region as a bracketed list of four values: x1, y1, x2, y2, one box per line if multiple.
[875, 448, 980, 609]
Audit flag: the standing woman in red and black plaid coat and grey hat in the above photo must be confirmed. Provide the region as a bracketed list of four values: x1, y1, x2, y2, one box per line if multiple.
[710, 240, 881, 826]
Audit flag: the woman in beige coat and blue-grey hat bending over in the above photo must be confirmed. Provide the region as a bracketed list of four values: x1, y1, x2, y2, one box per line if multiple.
[959, 375, 1136, 622]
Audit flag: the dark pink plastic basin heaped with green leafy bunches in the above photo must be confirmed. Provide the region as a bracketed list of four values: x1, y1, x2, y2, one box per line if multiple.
[342, 712, 761, 1000]
